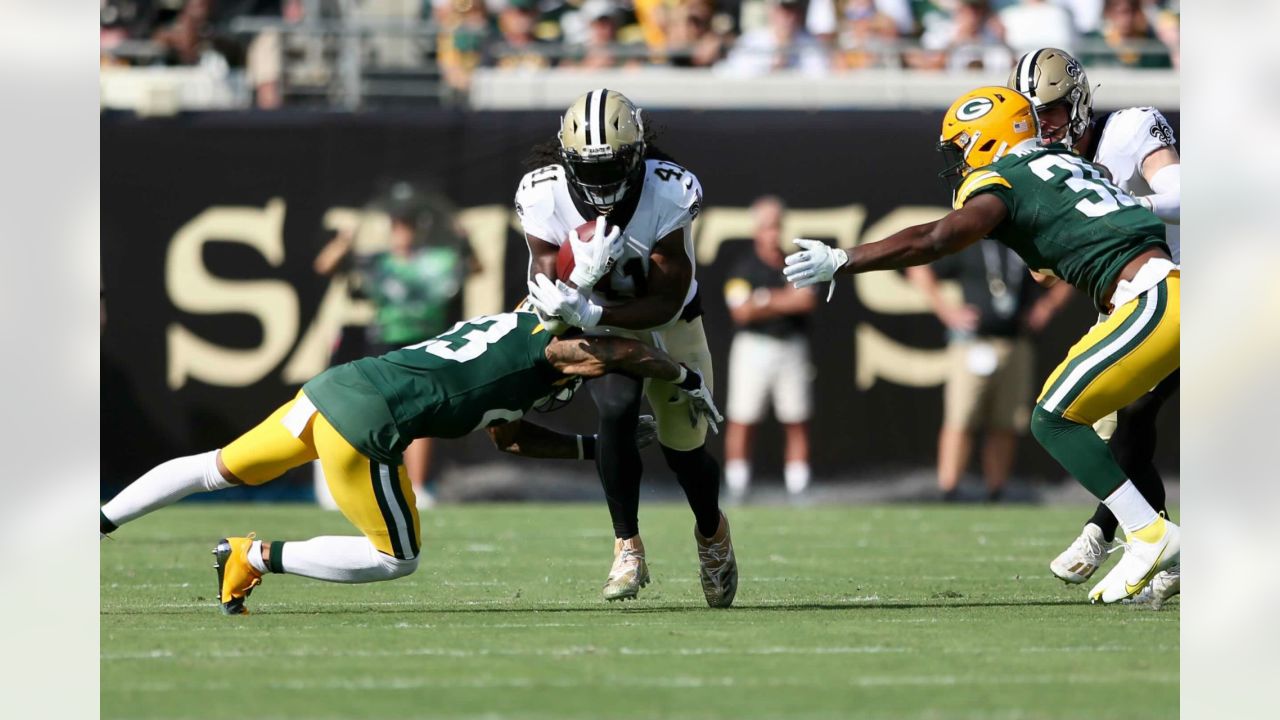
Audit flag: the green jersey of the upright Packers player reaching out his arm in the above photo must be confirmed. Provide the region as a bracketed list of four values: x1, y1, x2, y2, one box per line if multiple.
[954, 142, 1169, 310]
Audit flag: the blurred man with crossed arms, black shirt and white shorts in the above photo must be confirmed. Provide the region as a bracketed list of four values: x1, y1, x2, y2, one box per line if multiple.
[724, 196, 818, 500]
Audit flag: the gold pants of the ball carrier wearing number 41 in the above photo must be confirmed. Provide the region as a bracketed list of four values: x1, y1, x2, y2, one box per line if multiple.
[589, 316, 716, 450]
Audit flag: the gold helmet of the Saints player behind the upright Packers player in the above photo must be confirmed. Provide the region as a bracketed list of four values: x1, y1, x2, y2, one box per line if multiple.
[1009, 47, 1093, 147]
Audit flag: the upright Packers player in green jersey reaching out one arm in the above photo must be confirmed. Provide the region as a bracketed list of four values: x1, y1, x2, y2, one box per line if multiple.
[785, 87, 1181, 602]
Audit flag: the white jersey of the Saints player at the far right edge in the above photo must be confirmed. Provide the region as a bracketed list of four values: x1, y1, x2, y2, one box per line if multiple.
[1093, 108, 1181, 264]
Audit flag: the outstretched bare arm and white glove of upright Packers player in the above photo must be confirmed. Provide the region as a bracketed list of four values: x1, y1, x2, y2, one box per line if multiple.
[782, 193, 1009, 287]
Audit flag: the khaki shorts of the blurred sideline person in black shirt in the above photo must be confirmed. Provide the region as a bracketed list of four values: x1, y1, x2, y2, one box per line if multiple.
[943, 337, 1034, 433]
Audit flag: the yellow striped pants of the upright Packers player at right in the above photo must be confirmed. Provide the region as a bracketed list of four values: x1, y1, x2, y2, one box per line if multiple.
[1037, 270, 1181, 425]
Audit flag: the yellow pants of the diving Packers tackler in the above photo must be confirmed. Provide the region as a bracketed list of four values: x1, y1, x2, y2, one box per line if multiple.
[221, 392, 422, 560]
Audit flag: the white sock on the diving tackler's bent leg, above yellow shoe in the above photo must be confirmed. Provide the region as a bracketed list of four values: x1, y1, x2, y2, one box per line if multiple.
[280, 536, 417, 583]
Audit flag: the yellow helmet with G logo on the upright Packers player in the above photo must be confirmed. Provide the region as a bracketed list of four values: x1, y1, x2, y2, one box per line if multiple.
[938, 86, 1039, 190]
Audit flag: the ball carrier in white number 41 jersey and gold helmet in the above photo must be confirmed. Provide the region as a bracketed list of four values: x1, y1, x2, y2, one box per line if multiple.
[516, 88, 737, 607]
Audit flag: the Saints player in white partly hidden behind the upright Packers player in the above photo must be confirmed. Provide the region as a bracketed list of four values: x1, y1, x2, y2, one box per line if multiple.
[1009, 47, 1181, 607]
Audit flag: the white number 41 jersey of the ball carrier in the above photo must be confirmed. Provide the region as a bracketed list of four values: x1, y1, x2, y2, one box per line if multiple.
[516, 160, 703, 315]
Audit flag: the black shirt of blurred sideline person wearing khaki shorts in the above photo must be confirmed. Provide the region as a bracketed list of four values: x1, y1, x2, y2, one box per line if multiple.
[929, 238, 1039, 337]
